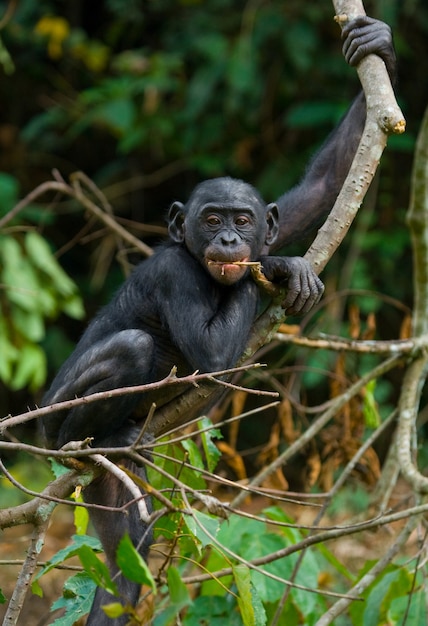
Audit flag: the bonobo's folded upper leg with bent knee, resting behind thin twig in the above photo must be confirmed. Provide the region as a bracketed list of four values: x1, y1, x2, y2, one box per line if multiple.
[43, 328, 153, 448]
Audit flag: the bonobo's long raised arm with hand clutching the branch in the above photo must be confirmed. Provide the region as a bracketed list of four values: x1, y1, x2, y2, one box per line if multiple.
[270, 16, 395, 251]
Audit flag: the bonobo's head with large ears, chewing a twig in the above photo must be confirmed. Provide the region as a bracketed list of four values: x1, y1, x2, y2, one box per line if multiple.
[168, 178, 278, 285]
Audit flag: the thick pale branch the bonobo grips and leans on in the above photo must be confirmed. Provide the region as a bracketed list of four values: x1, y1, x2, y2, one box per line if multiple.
[148, 0, 405, 435]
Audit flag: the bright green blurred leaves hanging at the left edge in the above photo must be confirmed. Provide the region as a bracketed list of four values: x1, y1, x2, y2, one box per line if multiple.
[0, 173, 84, 390]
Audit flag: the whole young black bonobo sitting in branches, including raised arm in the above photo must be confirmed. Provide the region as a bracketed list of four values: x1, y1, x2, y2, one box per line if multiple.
[43, 17, 394, 626]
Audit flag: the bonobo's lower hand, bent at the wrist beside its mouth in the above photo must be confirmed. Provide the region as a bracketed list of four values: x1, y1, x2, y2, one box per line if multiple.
[260, 256, 324, 315]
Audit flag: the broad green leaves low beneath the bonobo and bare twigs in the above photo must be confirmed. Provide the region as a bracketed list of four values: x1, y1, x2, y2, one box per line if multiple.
[29, 428, 426, 626]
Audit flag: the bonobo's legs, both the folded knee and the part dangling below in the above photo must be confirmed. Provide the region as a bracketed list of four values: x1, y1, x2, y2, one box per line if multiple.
[43, 330, 154, 626]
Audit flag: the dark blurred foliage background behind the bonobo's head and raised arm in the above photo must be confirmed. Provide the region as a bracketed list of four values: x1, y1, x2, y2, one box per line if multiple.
[0, 0, 428, 444]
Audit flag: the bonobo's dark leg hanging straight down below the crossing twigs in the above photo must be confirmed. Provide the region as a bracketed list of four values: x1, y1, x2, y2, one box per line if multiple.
[83, 425, 152, 626]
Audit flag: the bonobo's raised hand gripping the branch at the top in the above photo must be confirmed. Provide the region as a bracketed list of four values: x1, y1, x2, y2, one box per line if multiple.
[342, 15, 396, 81]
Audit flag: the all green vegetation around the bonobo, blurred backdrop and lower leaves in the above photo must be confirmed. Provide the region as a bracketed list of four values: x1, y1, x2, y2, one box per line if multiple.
[0, 0, 428, 626]
